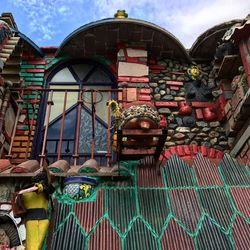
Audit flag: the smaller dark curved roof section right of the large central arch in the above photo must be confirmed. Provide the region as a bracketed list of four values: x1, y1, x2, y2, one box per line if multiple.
[189, 19, 242, 60]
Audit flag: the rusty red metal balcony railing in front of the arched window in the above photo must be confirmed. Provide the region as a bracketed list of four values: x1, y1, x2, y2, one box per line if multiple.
[7, 88, 122, 166]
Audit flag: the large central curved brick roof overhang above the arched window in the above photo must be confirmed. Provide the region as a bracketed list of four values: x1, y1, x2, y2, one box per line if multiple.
[57, 18, 189, 61]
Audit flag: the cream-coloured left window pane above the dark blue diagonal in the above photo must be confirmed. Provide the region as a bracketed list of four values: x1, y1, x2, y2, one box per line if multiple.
[49, 85, 79, 122]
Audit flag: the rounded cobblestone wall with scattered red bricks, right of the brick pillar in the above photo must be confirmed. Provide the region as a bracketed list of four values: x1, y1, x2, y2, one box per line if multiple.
[149, 59, 228, 151]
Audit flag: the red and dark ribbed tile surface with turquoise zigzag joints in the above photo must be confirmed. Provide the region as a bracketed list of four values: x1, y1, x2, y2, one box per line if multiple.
[48, 154, 250, 250]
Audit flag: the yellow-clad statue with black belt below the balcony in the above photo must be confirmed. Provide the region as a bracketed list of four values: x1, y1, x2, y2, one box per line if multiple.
[15, 170, 54, 250]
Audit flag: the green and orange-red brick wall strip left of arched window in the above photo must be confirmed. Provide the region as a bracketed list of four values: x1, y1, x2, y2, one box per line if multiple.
[11, 54, 45, 164]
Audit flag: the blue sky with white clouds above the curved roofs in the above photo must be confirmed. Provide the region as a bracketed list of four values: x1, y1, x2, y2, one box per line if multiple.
[0, 0, 250, 48]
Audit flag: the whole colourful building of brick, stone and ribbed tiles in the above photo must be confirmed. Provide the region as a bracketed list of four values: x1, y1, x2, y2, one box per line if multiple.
[0, 11, 250, 250]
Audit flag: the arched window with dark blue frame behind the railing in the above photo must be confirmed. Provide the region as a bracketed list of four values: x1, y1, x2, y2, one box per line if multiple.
[39, 61, 115, 164]
